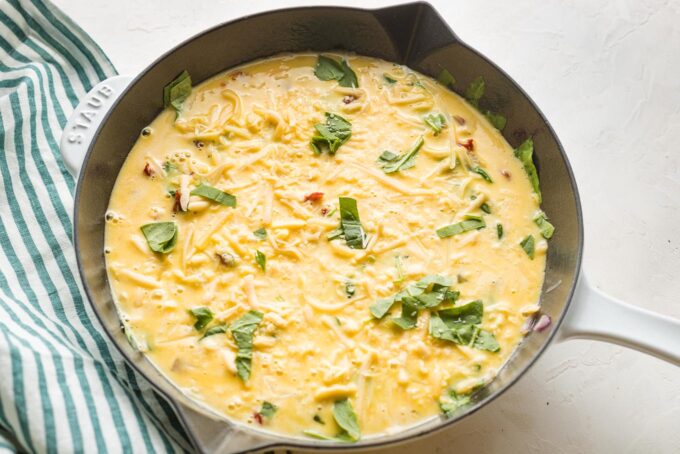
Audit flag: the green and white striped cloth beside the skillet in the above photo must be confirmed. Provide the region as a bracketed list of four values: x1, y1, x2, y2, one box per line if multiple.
[0, 0, 189, 453]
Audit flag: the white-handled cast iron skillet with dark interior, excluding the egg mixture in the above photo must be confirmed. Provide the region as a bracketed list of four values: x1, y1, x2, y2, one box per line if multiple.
[61, 3, 680, 452]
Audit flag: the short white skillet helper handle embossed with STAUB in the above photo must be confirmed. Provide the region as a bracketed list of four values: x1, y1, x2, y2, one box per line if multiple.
[59, 76, 132, 178]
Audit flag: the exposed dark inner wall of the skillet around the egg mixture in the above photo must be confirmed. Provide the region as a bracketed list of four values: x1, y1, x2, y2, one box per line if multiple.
[74, 3, 583, 449]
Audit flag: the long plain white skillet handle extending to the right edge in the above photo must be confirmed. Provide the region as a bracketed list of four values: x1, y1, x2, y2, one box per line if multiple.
[558, 273, 680, 366]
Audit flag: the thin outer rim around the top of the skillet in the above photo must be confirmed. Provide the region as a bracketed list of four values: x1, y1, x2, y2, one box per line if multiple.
[73, 1, 584, 452]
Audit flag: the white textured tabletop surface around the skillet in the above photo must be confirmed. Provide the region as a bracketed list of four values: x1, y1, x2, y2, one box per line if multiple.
[56, 0, 680, 454]
